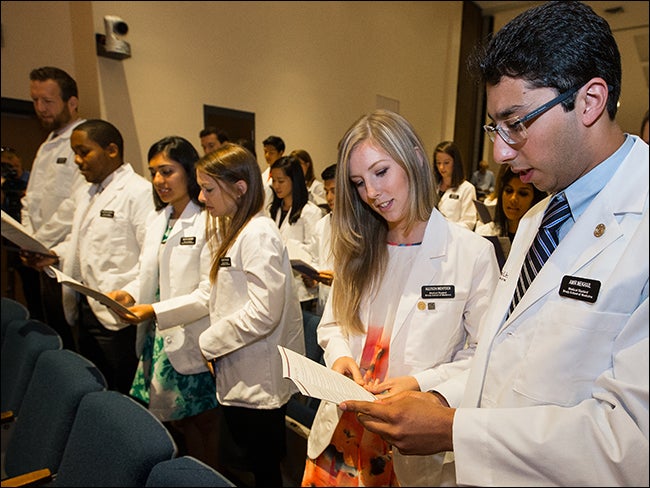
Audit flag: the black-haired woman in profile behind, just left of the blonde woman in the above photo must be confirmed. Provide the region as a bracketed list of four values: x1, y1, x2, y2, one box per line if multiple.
[269, 155, 323, 312]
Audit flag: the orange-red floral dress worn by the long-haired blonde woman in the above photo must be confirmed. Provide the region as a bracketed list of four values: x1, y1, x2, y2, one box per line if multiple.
[302, 244, 420, 486]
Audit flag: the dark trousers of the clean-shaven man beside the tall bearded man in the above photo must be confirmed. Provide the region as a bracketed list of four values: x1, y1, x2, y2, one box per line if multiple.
[78, 296, 138, 395]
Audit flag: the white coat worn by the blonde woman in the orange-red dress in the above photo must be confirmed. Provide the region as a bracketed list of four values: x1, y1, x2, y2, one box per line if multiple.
[307, 209, 499, 486]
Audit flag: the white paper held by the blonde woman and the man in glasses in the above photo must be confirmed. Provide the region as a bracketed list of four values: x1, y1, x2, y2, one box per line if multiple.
[278, 346, 376, 405]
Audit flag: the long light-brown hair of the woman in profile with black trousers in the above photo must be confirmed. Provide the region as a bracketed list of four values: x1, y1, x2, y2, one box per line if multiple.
[196, 143, 264, 284]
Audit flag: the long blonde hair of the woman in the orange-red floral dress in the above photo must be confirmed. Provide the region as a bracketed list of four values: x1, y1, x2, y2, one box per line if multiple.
[332, 110, 437, 334]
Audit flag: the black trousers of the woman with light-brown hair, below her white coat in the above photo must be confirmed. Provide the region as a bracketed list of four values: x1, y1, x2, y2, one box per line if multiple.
[219, 405, 287, 486]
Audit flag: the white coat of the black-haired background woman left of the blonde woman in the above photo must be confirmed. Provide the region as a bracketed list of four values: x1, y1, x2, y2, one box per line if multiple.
[275, 201, 323, 302]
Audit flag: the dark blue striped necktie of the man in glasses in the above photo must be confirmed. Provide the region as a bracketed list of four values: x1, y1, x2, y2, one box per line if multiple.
[508, 193, 571, 315]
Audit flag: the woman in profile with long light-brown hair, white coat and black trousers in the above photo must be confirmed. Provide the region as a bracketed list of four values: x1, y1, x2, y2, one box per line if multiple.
[196, 143, 305, 486]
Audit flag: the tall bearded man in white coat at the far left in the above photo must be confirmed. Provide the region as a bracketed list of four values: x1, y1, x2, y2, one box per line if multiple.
[22, 66, 88, 350]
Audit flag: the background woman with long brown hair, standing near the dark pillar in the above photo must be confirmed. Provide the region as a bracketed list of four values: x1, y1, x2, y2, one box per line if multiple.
[433, 141, 477, 230]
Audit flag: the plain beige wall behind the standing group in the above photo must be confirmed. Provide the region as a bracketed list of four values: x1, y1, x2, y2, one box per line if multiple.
[1, 1, 462, 174]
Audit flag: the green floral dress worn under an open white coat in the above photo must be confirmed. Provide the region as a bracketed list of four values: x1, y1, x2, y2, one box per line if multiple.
[129, 219, 218, 422]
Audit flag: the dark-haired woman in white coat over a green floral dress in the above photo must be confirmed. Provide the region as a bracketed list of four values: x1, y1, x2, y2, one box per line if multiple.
[109, 136, 218, 468]
